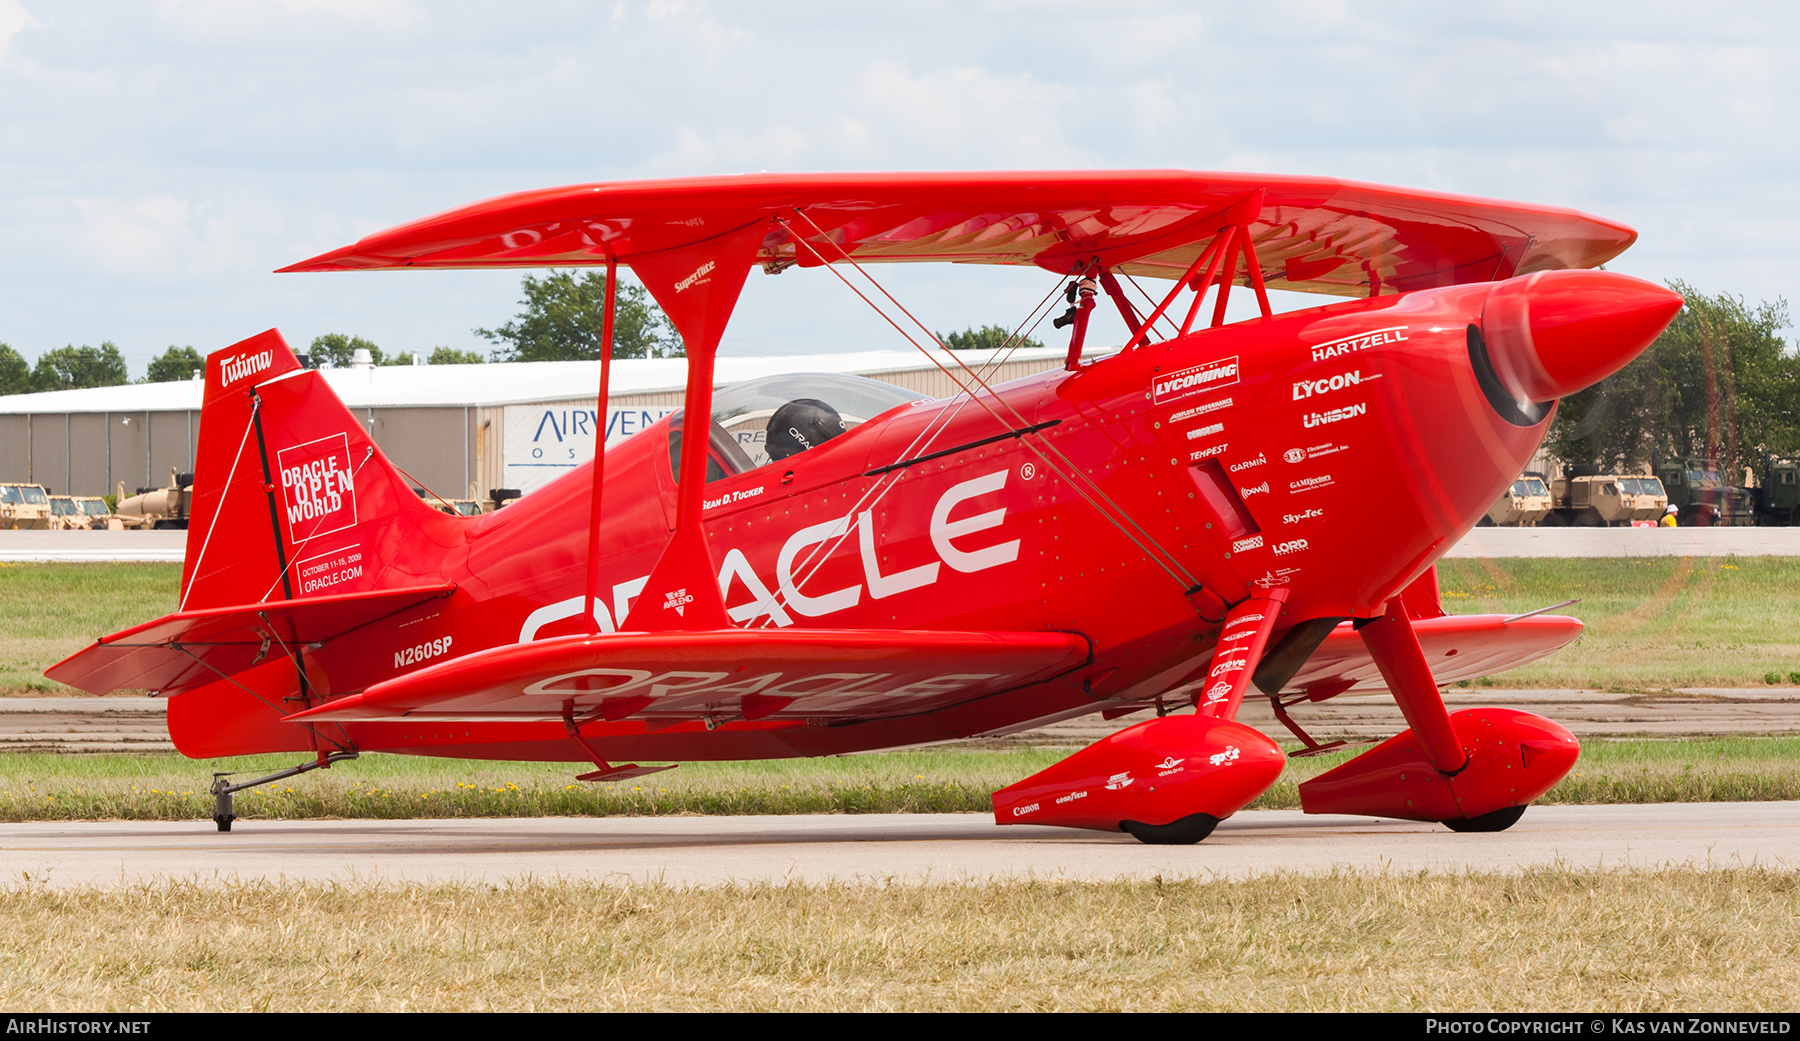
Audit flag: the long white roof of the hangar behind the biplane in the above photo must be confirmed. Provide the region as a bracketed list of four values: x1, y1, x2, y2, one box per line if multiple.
[0, 348, 1065, 414]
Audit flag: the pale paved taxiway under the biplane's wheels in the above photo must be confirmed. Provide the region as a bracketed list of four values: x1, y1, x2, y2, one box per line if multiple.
[0, 803, 1800, 888]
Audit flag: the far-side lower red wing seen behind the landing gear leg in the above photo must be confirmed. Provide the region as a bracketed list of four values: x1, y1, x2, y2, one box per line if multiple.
[1282, 614, 1582, 697]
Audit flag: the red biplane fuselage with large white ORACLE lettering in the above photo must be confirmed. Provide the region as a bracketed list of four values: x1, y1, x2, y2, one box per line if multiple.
[261, 285, 1546, 760]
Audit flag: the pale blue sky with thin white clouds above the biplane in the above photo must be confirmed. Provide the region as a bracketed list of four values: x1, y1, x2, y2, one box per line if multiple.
[0, 0, 1800, 375]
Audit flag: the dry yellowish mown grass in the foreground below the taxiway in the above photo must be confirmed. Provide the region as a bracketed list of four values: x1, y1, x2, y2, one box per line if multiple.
[0, 868, 1800, 1010]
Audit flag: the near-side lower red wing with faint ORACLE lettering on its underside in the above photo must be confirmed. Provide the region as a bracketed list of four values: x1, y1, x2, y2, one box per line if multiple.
[290, 629, 1091, 724]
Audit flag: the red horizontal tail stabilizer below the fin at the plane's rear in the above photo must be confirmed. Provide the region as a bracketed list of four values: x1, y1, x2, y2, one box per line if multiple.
[45, 582, 455, 693]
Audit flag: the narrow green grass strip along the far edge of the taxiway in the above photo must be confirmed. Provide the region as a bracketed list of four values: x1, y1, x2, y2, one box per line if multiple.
[0, 737, 1800, 821]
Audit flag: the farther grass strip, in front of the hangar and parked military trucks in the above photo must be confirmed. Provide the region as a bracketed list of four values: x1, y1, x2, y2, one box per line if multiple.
[0, 557, 1800, 697]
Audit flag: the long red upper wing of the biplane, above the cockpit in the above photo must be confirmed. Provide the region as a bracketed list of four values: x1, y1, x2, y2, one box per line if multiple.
[281, 171, 1636, 295]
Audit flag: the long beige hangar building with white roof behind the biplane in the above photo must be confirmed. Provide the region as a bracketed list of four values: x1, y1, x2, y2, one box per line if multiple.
[0, 348, 1065, 499]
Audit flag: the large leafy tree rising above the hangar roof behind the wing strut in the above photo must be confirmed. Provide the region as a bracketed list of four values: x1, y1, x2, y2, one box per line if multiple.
[475, 270, 688, 362]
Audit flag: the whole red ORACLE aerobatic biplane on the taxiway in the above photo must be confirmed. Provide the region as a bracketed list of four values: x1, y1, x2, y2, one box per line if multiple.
[47, 171, 1681, 843]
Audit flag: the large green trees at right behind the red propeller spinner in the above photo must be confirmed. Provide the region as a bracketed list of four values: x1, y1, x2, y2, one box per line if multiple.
[1548, 281, 1800, 484]
